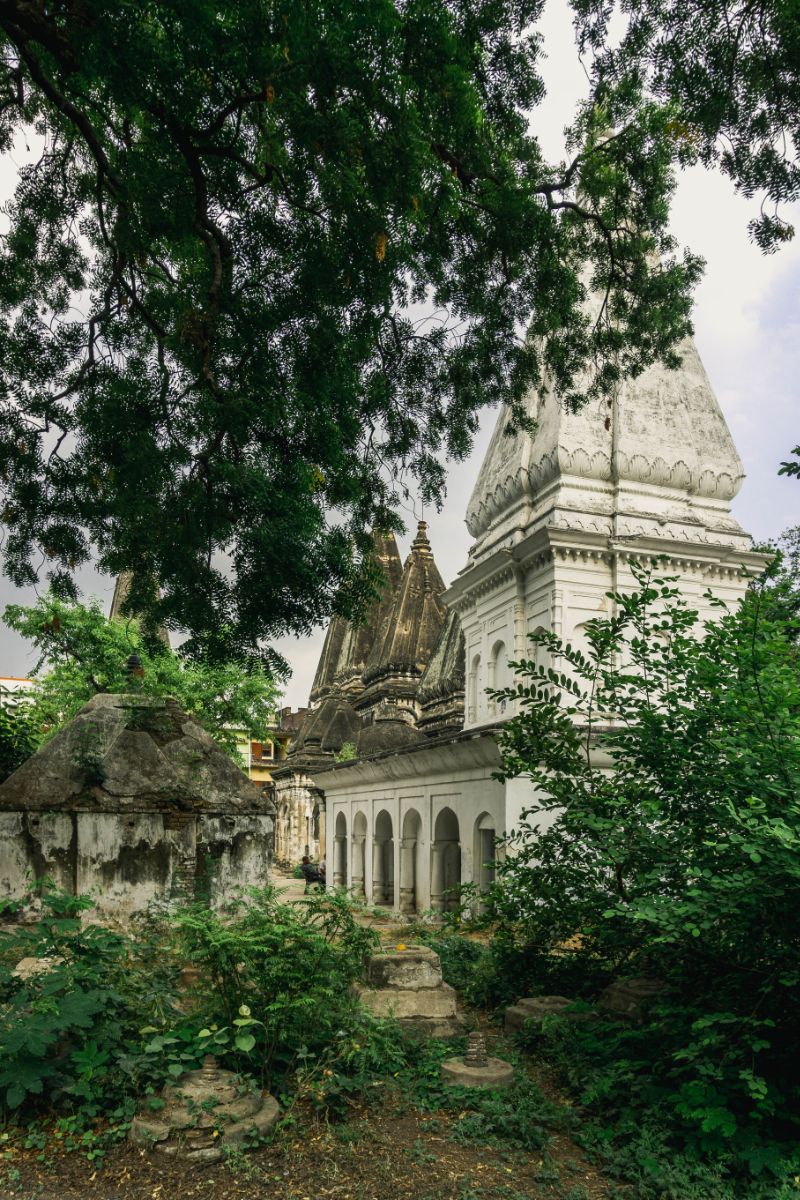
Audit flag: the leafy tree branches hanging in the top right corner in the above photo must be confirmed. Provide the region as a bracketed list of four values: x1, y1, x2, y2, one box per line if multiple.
[571, 0, 800, 251]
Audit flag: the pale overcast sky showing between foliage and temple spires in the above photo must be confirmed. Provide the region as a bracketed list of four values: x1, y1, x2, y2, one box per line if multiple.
[0, 0, 800, 708]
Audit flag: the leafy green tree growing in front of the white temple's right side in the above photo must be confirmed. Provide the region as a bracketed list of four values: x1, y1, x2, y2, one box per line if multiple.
[488, 570, 800, 1169]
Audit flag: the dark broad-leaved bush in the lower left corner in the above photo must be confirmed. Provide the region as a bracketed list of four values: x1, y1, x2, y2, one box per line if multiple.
[0, 883, 178, 1116]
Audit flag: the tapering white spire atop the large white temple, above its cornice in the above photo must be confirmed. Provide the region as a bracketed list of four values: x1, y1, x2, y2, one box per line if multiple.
[467, 338, 750, 562]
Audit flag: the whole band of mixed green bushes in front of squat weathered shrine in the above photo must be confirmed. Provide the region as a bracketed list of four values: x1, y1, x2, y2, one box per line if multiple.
[0, 883, 374, 1120]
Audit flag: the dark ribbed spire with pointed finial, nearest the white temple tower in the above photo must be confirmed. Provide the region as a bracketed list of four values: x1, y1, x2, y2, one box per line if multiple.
[363, 521, 447, 689]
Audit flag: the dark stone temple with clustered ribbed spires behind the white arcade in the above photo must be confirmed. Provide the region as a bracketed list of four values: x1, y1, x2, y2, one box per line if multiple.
[273, 521, 464, 863]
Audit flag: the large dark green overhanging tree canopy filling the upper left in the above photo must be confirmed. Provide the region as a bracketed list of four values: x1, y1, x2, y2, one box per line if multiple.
[0, 0, 699, 659]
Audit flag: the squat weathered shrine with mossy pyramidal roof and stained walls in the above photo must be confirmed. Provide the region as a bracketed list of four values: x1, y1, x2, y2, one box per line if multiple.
[0, 694, 275, 919]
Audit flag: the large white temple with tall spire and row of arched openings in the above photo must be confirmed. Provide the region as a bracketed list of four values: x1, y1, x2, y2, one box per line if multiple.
[277, 328, 763, 912]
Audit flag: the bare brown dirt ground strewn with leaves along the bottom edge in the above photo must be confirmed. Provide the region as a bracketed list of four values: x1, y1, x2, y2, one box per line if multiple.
[0, 1097, 619, 1200]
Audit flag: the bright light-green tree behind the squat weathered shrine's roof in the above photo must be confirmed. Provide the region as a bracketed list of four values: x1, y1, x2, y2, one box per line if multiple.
[2, 595, 279, 754]
